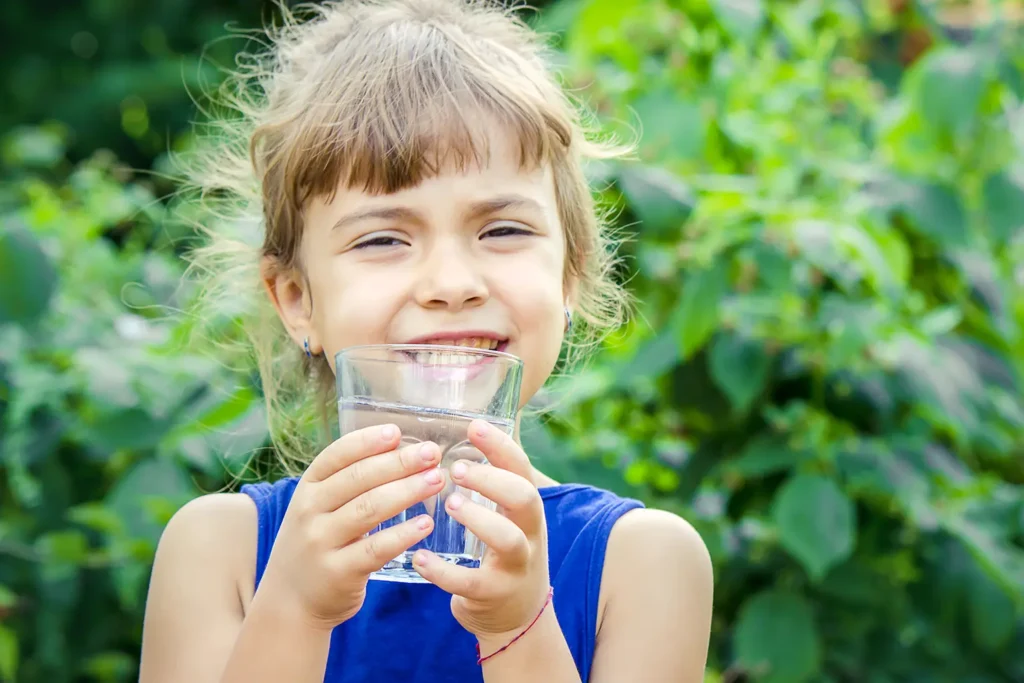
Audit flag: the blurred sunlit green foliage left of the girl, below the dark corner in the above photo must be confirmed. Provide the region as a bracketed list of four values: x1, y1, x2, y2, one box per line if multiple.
[0, 129, 266, 681]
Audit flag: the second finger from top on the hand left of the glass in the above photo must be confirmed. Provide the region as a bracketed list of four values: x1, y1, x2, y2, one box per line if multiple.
[317, 441, 441, 511]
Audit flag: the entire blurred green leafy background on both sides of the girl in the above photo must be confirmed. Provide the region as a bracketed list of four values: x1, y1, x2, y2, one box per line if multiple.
[0, 0, 1024, 683]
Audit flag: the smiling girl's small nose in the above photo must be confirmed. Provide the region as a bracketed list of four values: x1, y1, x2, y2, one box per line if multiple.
[416, 241, 489, 311]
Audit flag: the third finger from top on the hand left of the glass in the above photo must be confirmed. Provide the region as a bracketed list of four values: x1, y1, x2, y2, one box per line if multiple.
[330, 467, 444, 543]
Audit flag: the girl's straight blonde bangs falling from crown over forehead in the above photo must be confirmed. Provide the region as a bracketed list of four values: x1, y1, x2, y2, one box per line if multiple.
[268, 20, 572, 209]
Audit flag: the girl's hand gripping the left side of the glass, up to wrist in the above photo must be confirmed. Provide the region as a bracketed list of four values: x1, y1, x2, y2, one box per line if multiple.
[257, 425, 443, 629]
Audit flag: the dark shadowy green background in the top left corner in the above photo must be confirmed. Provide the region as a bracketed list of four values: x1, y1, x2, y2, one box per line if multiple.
[0, 0, 264, 168]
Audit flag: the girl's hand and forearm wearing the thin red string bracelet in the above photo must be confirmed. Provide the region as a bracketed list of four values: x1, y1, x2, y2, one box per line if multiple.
[413, 420, 585, 683]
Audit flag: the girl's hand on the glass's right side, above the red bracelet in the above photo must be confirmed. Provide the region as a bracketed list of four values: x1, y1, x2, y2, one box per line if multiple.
[413, 420, 549, 640]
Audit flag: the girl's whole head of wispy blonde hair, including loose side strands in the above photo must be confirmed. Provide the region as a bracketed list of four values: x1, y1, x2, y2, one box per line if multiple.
[187, 0, 627, 472]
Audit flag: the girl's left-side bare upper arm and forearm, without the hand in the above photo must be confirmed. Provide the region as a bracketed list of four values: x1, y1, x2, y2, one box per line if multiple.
[139, 494, 330, 683]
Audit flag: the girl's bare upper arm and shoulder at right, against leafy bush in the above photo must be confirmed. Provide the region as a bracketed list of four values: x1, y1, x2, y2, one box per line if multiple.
[589, 509, 714, 683]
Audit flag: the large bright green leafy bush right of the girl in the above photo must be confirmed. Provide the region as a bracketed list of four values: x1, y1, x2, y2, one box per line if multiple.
[532, 0, 1024, 682]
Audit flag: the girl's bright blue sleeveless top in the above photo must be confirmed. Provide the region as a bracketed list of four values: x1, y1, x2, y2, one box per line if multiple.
[242, 478, 643, 683]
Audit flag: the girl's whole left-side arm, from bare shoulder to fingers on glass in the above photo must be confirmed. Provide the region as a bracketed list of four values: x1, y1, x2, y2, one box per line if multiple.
[140, 425, 444, 683]
